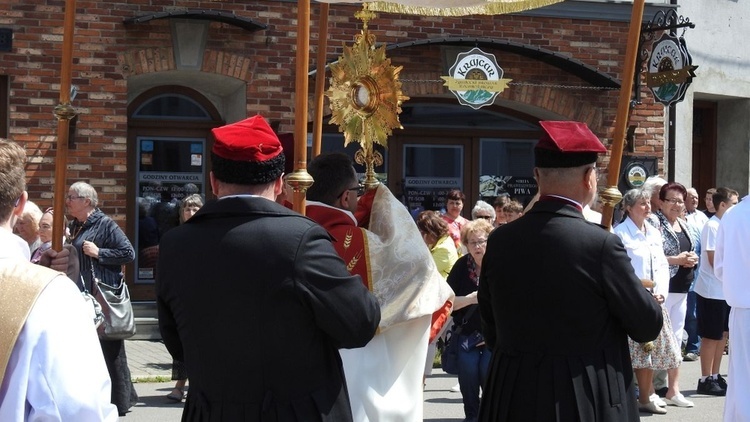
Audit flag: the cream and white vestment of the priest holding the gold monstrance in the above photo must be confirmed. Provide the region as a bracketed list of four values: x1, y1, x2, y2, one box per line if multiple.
[322, 185, 455, 422]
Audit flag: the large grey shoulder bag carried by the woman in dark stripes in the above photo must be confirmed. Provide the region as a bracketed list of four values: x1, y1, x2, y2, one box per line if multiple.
[91, 263, 135, 340]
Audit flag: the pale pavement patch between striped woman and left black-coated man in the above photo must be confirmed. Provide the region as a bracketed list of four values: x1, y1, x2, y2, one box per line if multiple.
[125, 340, 172, 381]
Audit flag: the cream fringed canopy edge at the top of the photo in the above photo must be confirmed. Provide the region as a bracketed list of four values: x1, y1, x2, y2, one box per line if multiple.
[318, 0, 563, 16]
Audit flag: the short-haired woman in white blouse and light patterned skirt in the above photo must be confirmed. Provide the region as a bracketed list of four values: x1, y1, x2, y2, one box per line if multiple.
[614, 189, 682, 414]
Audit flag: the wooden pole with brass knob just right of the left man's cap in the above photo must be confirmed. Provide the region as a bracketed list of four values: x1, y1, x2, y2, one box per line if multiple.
[287, 0, 313, 214]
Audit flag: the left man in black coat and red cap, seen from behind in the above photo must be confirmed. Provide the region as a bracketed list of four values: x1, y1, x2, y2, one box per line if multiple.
[157, 116, 380, 422]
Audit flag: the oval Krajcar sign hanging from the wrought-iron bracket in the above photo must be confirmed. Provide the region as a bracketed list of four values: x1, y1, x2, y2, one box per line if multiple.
[646, 33, 698, 106]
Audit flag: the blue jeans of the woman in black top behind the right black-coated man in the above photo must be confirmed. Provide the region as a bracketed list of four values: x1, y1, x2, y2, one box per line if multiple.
[458, 335, 492, 420]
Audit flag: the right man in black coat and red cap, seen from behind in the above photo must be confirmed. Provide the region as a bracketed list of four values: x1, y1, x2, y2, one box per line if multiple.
[478, 122, 663, 422]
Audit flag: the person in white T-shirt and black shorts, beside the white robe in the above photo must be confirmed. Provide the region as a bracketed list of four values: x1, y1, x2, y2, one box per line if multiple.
[695, 188, 738, 396]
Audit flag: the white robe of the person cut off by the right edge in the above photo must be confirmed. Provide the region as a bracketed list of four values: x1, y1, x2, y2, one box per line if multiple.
[714, 192, 750, 422]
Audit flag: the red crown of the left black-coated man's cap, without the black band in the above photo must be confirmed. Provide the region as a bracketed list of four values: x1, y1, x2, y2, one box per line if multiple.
[211, 115, 283, 162]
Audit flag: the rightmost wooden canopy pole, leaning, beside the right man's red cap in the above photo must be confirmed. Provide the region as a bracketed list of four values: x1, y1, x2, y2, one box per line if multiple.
[599, 0, 644, 229]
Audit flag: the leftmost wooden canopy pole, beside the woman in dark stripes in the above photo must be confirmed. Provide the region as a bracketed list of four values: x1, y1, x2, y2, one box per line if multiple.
[52, 0, 76, 251]
